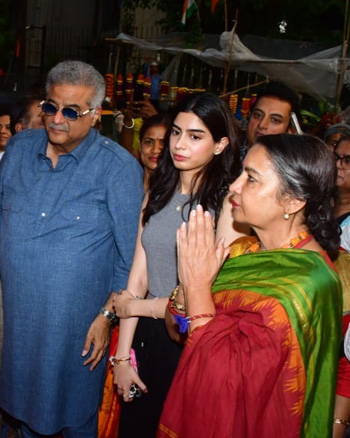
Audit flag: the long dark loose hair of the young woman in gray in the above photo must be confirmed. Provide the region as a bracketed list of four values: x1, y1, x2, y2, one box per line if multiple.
[142, 94, 240, 224]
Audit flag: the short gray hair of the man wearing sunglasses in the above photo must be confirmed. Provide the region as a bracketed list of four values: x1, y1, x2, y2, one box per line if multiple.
[46, 61, 106, 108]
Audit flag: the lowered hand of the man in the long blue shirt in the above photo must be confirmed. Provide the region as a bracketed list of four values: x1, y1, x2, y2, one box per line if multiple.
[81, 315, 110, 371]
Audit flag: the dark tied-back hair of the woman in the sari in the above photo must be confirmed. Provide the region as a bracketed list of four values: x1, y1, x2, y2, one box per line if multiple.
[257, 134, 341, 251]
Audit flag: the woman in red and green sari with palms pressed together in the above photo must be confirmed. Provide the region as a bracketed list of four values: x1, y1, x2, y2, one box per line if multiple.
[159, 134, 342, 438]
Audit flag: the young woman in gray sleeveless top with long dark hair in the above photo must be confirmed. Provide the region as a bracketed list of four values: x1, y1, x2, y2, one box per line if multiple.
[114, 94, 240, 438]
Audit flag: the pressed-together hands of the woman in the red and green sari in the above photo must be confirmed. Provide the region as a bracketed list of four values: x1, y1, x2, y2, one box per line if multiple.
[177, 205, 229, 293]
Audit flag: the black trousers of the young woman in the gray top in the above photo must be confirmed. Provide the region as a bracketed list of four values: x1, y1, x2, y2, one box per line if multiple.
[118, 318, 182, 438]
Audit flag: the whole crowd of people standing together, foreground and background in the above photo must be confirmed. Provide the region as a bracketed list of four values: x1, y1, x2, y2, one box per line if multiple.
[0, 61, 350, 438]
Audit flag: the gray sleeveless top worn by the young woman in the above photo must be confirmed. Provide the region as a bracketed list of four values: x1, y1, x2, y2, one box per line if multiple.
[141, 190, 189, 298]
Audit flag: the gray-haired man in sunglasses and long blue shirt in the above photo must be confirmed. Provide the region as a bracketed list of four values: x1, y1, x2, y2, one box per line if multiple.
[0, 61, 143, 438]
